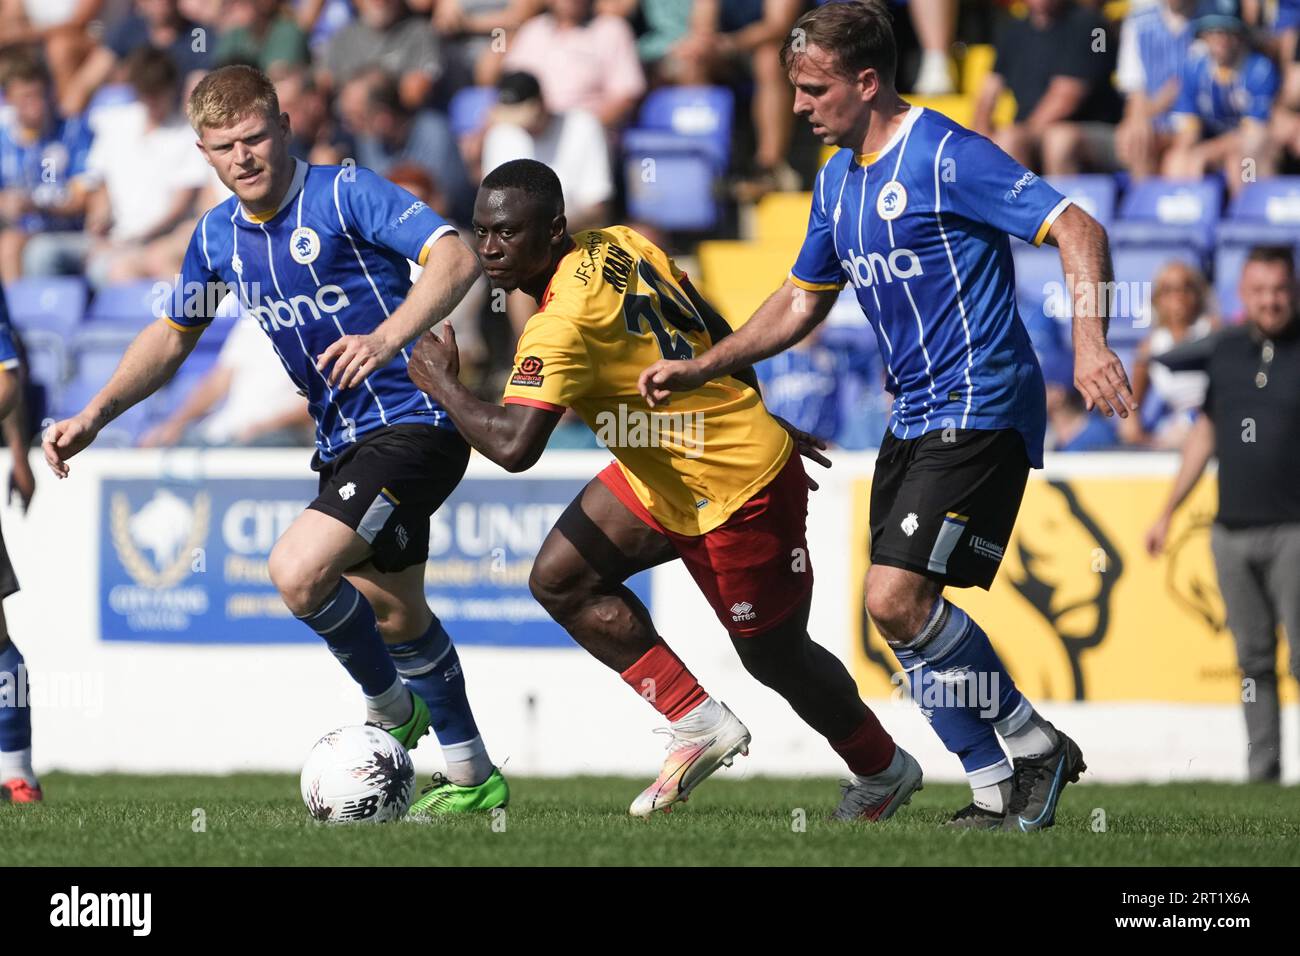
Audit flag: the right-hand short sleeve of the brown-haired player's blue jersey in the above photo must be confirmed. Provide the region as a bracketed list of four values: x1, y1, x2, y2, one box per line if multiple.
[940, 135, 1070, 246]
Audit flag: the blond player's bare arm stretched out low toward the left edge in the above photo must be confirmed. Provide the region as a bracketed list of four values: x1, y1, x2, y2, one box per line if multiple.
[42, 319, 205, 477]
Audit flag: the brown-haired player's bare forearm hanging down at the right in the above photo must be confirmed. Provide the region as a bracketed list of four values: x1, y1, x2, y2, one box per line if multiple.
[1047, 206, 1134, 418]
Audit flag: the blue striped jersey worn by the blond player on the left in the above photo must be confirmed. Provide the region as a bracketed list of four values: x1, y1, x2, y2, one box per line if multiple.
[168, 160, 455, 462]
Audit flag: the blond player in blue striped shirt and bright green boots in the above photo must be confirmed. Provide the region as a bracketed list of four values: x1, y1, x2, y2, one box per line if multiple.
[44, 66, 508, 813]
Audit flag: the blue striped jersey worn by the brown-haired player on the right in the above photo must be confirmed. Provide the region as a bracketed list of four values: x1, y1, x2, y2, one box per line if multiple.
[790, 107, 1070, 467]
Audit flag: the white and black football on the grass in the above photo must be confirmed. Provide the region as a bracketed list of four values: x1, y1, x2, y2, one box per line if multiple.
[300, 726, 415, 823]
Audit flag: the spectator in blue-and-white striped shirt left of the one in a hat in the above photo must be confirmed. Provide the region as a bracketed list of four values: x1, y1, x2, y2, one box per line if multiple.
[1102, 0, 1196, 179]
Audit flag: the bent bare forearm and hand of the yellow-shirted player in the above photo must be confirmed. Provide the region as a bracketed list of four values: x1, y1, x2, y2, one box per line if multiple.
[407, 324, 560, 472]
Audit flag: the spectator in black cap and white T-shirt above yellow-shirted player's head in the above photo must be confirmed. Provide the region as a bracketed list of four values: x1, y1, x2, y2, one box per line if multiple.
[482, 73, 614, 233]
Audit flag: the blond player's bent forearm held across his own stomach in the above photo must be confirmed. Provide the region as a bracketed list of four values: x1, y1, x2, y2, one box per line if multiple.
[316, 233, 478, 389]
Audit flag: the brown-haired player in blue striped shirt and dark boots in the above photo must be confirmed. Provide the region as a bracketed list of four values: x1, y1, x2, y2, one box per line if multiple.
[640, 0, 1131, 831]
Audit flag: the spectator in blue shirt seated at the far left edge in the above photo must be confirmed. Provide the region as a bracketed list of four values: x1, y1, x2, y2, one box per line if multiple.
[0, 56, 91, 282]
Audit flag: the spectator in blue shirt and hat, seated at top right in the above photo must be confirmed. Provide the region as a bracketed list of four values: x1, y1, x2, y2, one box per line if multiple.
[1164, 0, 1279, 194]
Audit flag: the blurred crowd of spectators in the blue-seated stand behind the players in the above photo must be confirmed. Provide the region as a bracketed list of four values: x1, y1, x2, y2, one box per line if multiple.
[0, 0, 1300, 450]
